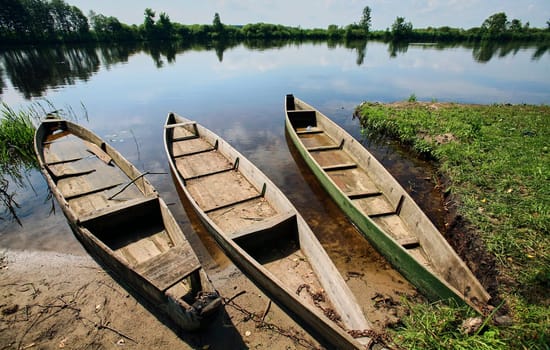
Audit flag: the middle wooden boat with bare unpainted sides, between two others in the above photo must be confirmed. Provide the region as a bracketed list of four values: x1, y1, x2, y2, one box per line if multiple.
[164, 113, 380, 349]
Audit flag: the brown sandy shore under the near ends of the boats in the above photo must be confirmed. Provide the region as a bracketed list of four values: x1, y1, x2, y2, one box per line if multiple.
[0, 250, 319, 350]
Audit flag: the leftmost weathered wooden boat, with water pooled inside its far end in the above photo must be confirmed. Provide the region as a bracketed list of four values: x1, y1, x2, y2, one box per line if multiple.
[34, 119, 221, 331]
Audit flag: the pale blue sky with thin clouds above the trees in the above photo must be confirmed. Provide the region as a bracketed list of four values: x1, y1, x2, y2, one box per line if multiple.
[65, 0, 550, 30]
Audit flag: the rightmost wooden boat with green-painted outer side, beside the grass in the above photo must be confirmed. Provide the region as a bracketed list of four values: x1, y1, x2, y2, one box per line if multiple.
[285, 95, 490, 312]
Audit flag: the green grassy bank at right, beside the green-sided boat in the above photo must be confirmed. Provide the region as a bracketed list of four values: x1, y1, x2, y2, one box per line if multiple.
[357, 102, 550, 349]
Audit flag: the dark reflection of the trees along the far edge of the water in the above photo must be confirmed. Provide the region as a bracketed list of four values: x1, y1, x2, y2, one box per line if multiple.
[0, 40, 550, 99]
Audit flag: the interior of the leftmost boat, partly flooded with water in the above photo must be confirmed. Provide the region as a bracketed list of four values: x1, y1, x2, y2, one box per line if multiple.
[38, 124, 201, 302]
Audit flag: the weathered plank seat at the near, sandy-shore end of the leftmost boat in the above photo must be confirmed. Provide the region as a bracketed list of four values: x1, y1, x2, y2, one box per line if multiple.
[135, 243, 201, 292]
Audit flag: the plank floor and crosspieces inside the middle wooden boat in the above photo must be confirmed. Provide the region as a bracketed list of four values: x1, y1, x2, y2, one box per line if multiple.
[166, 118, 340, 310]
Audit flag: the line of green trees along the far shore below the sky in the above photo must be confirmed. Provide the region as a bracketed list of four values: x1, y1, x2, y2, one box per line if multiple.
[0, 0, 550, 44]
